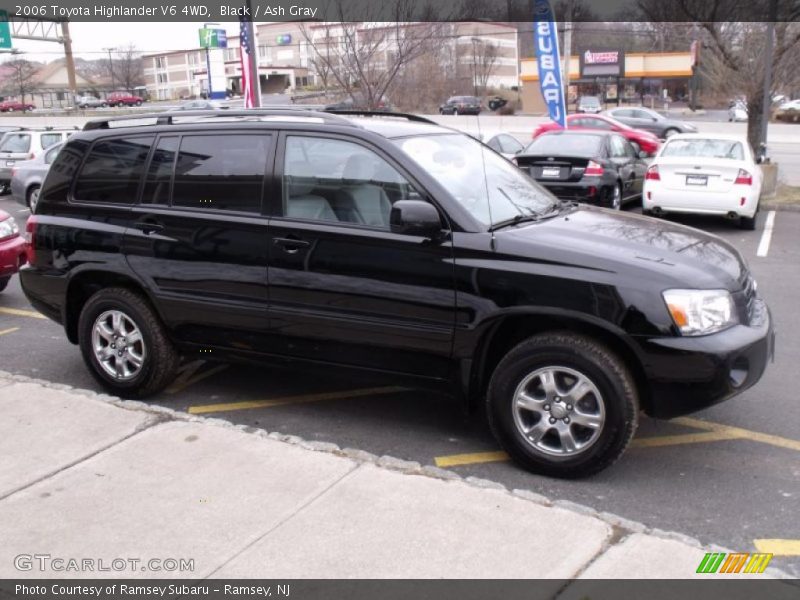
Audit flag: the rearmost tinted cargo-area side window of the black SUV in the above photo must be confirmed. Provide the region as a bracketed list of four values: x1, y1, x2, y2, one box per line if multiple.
[74, 135, 154, 204]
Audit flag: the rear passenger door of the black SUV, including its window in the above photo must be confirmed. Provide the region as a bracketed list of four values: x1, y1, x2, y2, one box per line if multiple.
[125, 130, 274, 352]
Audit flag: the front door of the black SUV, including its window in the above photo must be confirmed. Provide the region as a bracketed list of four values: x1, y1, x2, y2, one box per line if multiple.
[269, 133, 455, 378]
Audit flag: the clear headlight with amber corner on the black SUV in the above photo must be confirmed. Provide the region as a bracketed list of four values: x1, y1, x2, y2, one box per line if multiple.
[663, 290, 739, 335]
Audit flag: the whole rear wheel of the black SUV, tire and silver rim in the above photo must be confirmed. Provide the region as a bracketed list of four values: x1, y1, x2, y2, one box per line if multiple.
[78, 288, 179, 398]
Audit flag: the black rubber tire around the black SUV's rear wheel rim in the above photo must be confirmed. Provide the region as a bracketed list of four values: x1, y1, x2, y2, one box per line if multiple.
[78, 288, 180, 398]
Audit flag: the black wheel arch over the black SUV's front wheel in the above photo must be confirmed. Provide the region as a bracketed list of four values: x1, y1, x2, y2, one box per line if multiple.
[462, 311, 650, 411]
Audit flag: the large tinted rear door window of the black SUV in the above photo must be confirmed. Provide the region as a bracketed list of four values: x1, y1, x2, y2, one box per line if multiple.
[172, 134, 270, 213]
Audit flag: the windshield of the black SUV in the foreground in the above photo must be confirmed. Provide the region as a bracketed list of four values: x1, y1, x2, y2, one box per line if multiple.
[395, 134, 559, 226]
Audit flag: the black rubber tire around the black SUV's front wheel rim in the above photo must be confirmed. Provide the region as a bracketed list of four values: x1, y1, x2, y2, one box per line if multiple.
[487, 331, 639, 479]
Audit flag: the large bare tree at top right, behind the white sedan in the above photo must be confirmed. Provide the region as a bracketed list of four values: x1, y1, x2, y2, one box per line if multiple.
[637, 0, 800, 149]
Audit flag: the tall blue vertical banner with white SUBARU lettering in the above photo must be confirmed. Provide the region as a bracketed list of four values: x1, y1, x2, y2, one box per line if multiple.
[533, 0, 567, 127]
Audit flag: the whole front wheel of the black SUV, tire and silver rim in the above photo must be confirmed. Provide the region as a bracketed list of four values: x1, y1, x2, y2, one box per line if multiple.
[487, 332, 639, 478]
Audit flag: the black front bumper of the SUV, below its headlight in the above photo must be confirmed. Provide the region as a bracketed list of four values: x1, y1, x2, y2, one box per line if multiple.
[637, 298, 775, 418]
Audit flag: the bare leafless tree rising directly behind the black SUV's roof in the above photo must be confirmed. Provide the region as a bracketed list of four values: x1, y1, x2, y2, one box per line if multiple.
[302, 0, 443, 109]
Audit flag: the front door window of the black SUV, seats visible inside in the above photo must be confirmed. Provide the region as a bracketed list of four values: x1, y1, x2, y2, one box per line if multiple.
[283, 136, 420, 229]
